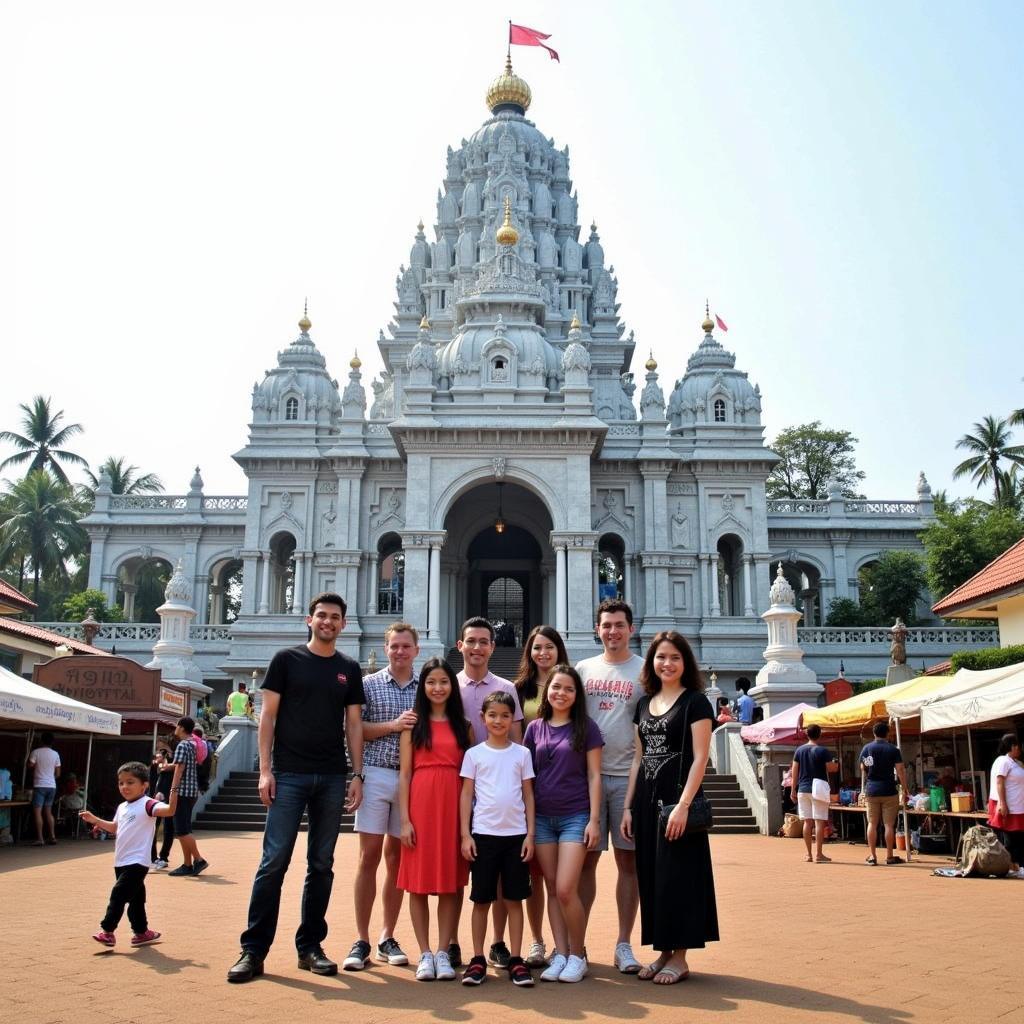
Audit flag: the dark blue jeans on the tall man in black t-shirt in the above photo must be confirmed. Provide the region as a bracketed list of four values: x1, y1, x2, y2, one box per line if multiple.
[241, 772, 345, 958]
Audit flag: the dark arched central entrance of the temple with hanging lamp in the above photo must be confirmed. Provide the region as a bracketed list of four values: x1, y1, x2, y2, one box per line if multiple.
[441, 481, 555, 647]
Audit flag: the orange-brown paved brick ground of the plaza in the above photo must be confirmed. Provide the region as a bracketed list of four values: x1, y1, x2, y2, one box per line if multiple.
[0, 833, 1024, 1024]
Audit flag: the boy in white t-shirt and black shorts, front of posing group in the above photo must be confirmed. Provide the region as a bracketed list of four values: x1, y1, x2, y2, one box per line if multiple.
[460, 690, 534, 987]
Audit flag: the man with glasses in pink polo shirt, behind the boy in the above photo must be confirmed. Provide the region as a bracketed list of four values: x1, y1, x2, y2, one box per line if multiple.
[449, 615, 523, 968]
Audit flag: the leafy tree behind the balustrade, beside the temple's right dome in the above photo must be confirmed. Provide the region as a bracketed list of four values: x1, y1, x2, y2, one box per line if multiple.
[765, 420, 864, 499]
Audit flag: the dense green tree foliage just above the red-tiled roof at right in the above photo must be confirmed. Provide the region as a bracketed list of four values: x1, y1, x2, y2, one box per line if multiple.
[921, 501, 1024, 600]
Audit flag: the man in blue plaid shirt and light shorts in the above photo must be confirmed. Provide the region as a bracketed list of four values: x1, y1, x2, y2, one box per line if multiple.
[342, 623, 420, 971]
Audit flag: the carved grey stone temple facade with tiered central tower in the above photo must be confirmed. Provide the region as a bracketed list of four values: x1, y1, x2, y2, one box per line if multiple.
[84, 59, 932, 688]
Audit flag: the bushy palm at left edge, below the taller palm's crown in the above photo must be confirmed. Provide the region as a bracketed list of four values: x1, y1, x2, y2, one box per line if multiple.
[0, 469, 88, 604]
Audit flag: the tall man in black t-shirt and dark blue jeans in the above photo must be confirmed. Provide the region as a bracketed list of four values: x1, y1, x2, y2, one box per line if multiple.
[227, 594, 364, 982]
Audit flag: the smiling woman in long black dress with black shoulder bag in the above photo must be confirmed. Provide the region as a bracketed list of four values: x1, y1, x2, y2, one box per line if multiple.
[622, 631, 719, 985]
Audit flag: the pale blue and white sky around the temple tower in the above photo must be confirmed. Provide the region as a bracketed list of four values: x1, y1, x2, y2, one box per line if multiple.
[0, 0, 1024, 499]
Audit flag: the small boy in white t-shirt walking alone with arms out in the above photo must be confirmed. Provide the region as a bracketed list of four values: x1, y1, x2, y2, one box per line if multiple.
[79, 761, 178, 946]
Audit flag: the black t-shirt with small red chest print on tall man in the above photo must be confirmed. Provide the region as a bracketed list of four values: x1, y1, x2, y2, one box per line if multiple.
[263, 644, 364, 775]
